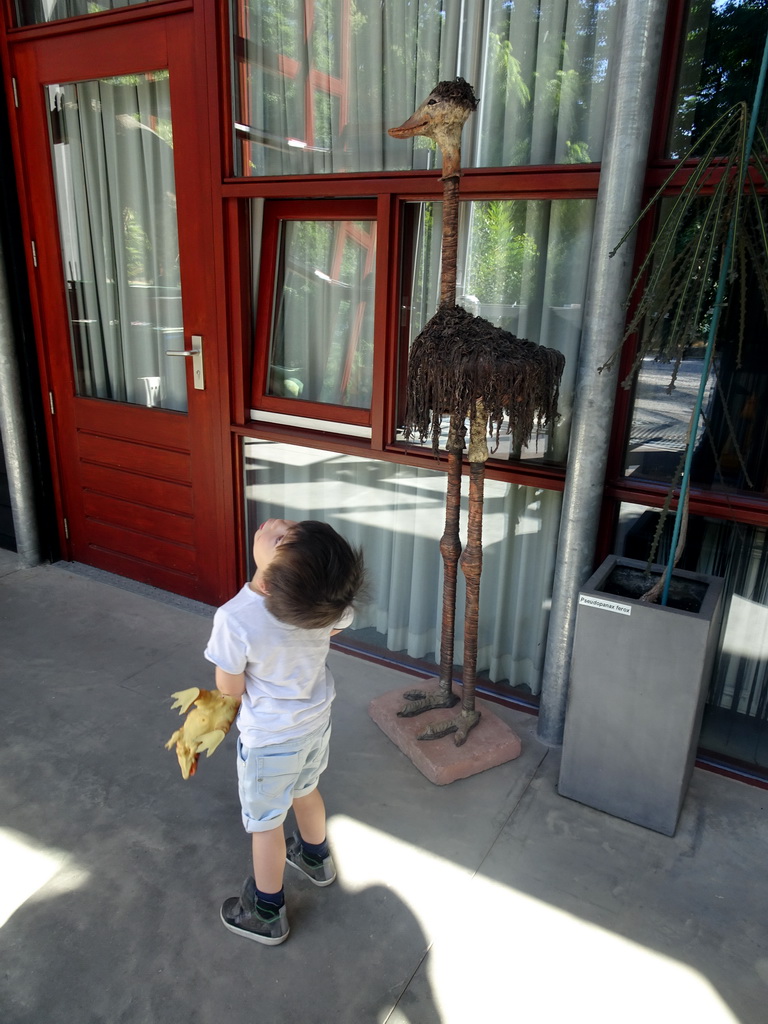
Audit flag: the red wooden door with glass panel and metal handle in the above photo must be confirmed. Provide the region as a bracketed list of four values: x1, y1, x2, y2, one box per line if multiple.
[11, 13, 234, 603]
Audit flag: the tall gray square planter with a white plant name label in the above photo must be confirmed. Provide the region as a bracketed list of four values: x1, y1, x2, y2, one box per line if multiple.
[558, 555, 723, 836]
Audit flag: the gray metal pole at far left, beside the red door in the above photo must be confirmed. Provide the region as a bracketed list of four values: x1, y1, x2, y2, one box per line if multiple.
[0, 230, 40, 566]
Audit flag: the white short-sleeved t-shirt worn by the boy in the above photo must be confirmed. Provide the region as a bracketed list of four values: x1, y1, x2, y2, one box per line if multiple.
[205, 584, 353, 746]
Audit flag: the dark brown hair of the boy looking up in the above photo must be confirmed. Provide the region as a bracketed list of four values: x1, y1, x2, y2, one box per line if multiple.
[264, 519, 366, 629]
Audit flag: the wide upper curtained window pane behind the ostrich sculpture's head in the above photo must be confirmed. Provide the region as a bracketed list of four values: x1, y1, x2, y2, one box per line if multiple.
[230, 0, 620, 176]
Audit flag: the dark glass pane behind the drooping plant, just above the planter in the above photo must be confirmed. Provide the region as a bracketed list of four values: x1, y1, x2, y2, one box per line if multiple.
[625, 203, 768, 494]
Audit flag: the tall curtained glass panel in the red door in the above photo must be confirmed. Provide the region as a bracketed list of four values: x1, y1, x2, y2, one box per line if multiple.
[47, 71, 186, 411]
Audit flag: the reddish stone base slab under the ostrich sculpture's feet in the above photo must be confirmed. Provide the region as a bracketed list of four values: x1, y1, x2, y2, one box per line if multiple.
[368, 688, 522, 785]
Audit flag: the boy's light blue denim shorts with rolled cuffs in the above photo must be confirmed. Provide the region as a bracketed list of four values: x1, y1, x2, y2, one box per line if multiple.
[238, 717, 331, 833]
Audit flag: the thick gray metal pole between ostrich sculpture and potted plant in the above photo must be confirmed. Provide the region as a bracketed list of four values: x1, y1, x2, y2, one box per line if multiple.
[538, 0, 667, 745]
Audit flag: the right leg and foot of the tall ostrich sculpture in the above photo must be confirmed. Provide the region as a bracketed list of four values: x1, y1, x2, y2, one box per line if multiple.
[419, 400, 488, 746]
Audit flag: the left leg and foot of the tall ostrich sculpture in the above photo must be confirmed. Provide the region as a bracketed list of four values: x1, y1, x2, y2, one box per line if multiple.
[397, 417, 465, 718]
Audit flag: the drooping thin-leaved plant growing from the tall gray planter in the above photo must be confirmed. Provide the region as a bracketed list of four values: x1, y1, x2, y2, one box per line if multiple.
[598, 95, 768, 603]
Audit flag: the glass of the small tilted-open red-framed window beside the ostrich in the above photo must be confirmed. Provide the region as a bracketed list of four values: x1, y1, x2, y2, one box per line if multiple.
[267, 220, 376, 409]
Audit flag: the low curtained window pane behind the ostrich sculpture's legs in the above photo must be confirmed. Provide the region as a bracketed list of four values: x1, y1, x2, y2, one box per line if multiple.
[244, 438, 561, 693]
